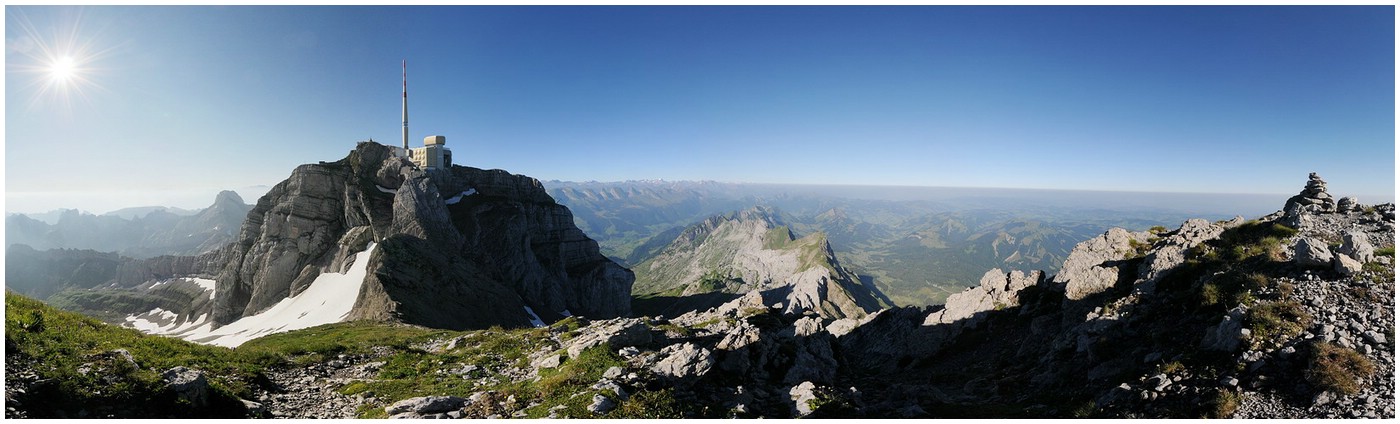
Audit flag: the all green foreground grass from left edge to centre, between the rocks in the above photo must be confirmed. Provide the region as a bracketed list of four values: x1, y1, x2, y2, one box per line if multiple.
[6, 292, 683, 418]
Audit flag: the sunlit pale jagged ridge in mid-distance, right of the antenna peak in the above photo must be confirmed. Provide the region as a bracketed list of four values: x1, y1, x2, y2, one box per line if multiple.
[633, 207, 892, 319]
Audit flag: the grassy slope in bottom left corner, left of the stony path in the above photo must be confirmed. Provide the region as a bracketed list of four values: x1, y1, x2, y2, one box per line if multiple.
[6, 292, 279, 417]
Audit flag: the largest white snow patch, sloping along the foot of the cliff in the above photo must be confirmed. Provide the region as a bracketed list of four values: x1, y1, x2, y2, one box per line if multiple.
[139, 243, 375, 347]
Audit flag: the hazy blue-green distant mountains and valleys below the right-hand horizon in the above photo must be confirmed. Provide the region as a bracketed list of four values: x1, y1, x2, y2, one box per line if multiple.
[545, 181, 1277, 305]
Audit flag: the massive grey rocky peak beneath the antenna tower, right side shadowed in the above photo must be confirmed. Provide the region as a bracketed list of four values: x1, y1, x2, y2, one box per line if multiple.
[214, 143, 633, 329]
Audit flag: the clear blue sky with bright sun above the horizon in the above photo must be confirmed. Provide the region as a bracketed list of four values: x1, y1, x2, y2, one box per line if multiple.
[4, 6, 1396, 213]
